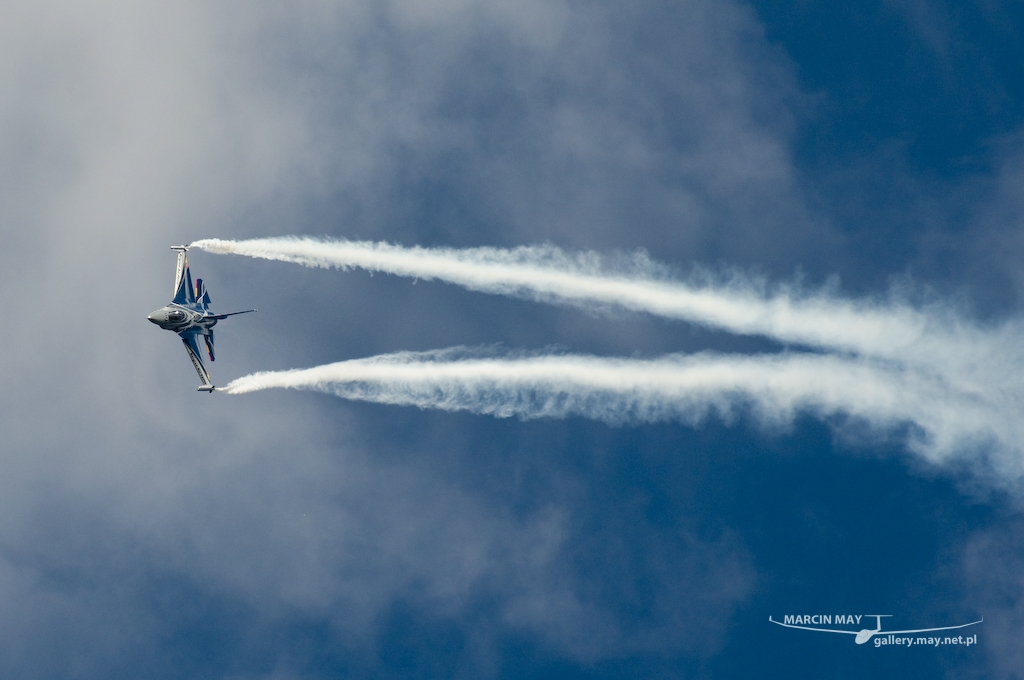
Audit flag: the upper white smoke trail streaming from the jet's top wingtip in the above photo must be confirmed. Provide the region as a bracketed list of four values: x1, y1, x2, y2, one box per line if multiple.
[191, 237, 1024, 393]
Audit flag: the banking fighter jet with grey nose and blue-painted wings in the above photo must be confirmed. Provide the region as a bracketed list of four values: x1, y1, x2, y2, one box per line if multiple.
[146, 246, 257, 394]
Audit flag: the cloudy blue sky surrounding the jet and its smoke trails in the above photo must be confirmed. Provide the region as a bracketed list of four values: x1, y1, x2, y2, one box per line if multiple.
[0, 0, 1024, 679]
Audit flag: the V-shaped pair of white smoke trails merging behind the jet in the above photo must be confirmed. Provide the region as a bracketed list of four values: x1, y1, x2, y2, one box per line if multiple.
[193, 238, 1024, 476]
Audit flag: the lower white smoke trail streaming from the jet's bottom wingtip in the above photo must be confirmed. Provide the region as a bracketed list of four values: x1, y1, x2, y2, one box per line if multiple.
[223, 348, 1011, 460]
